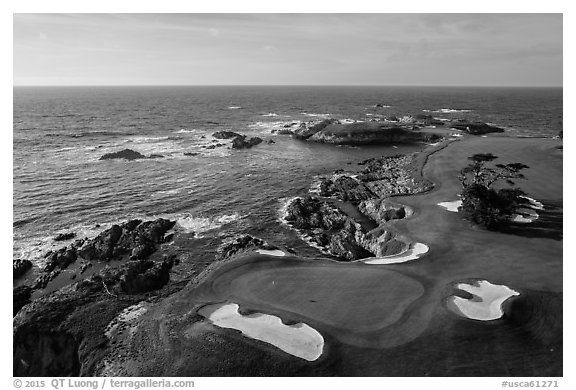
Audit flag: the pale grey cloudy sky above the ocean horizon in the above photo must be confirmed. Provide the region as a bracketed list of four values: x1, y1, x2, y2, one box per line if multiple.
[14, 14, 562, 86]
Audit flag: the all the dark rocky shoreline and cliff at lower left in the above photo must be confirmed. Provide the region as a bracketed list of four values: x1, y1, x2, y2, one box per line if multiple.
[13, 218, 184, 376]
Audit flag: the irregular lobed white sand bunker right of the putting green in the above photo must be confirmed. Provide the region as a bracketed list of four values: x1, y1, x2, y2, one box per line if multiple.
[452, 280, 520, 321]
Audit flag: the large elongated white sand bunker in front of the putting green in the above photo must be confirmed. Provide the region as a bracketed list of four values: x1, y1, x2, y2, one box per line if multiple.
[198, 303, 324, 361]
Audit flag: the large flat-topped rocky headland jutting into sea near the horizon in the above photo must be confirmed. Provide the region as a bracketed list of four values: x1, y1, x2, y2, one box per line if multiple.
[307, 122, 441, 145]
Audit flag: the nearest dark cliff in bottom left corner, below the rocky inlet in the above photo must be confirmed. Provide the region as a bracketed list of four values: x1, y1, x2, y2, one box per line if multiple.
[13, 254, 174, 376]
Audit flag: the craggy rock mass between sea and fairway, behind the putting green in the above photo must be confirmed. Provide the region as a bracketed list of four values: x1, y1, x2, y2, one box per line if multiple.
[283, 154, 433, 261]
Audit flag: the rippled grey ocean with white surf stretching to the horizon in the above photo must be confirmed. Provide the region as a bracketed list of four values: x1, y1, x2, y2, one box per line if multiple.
[13, 86, 562, 274]
